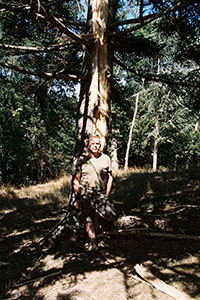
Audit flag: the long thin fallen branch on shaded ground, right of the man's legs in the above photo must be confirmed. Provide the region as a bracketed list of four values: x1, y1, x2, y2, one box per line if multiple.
[98, 228, 200, 241]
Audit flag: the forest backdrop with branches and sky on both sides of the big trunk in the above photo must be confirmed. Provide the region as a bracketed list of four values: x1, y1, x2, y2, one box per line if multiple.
[0, 0, 200, 187]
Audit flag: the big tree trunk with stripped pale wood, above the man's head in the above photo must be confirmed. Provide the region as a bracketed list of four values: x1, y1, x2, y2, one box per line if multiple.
[75, 0, 116, 162]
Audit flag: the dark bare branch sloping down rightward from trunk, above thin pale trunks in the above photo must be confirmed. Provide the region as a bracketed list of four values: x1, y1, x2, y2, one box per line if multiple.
[114, 57, 198, 87]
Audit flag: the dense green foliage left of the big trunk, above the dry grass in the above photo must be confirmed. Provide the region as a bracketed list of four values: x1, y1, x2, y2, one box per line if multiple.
[0, 73, 77, 185]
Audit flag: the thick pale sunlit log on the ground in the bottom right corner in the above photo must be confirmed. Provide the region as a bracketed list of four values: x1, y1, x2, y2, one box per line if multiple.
[134, 264, 193, 300]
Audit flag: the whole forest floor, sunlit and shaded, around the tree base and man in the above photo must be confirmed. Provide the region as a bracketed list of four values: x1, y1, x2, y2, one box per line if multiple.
[0, 168, 200, 300]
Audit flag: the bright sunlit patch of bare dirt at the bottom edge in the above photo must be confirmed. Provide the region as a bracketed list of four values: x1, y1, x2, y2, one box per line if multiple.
[36, 268, 173, 300]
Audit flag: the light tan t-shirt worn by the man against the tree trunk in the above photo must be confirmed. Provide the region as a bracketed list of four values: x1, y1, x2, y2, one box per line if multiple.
[79, 153, 112, 192]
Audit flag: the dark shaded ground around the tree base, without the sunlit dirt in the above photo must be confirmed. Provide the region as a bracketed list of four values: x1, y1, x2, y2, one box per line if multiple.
[0, 168, 200, 300]
